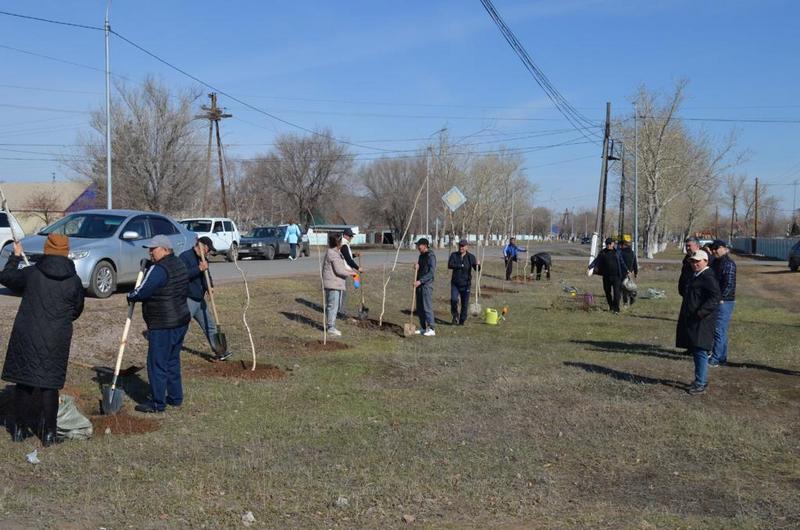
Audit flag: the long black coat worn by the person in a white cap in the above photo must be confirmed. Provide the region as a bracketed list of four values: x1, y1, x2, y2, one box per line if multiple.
[675, 267, 721, 350]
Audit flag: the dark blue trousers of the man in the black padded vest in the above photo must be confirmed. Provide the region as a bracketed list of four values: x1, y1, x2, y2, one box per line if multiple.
[147, 324, 189, 410]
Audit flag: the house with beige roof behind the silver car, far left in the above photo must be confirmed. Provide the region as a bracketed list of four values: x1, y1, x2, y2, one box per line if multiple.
[2, 181, 97, 235]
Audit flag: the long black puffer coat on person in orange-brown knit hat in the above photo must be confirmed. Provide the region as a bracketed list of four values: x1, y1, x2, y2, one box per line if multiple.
[0, 256, 83, 390]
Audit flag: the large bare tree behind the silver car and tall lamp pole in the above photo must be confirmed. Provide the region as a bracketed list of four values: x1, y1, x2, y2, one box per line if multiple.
[66, 77, 205, 213]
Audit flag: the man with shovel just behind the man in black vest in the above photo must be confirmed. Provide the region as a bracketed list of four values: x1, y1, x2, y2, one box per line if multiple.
[180, 236, 231, 361]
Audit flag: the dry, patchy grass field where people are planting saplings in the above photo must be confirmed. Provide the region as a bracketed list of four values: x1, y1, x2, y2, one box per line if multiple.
[0, 251, 800, 529]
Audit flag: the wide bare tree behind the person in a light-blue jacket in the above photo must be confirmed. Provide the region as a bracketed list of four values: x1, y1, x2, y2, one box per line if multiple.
[248, 131, 353, 222]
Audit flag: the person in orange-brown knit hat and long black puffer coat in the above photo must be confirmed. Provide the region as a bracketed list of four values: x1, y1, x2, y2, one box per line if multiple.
[0, 234, 83, 447]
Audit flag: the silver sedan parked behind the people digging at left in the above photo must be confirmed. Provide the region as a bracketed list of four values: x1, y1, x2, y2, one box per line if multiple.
[0, 210, 196, 298]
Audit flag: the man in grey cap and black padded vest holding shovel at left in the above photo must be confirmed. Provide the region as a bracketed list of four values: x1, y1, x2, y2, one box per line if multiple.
[128, 235, 192, 413]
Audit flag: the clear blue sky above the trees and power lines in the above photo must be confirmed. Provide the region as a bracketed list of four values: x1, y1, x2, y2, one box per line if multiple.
[0, 0, 800, 214]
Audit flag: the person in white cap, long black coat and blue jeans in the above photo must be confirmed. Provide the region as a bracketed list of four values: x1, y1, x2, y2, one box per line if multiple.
[675, 250, 721, 395]
